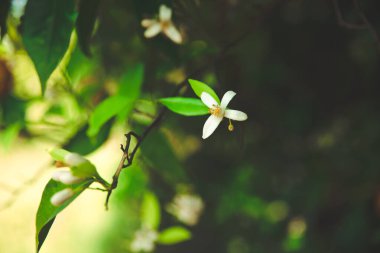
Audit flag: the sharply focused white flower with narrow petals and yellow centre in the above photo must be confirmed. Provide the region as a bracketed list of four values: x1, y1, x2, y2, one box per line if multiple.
[201, 91, 248, 139]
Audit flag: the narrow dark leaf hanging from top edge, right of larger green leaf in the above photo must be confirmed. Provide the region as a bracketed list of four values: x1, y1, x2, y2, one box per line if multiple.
[75, 0, 100, 56]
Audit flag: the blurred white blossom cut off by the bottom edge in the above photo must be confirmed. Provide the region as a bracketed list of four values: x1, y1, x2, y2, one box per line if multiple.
[130, 227, 158, 252]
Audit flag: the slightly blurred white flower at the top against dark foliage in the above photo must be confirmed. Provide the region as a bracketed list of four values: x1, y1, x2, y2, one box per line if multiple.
[141, 5, 182, 44]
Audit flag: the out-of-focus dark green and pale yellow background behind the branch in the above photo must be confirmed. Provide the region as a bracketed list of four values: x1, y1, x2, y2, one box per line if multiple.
[0, 0, 380, 253]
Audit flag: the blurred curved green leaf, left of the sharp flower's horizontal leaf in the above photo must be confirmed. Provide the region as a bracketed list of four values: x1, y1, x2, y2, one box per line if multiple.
[87, 96, 133, 137]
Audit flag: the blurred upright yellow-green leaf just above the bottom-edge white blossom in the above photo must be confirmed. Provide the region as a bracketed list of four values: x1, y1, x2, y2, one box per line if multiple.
[141, 192, 161, 230]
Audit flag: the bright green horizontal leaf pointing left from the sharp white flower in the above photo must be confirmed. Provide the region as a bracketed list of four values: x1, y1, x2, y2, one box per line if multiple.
[160, 97, 209, 116]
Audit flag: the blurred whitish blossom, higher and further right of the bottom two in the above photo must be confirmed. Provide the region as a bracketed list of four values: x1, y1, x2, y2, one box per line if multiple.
[167, 194, 204, 226]
